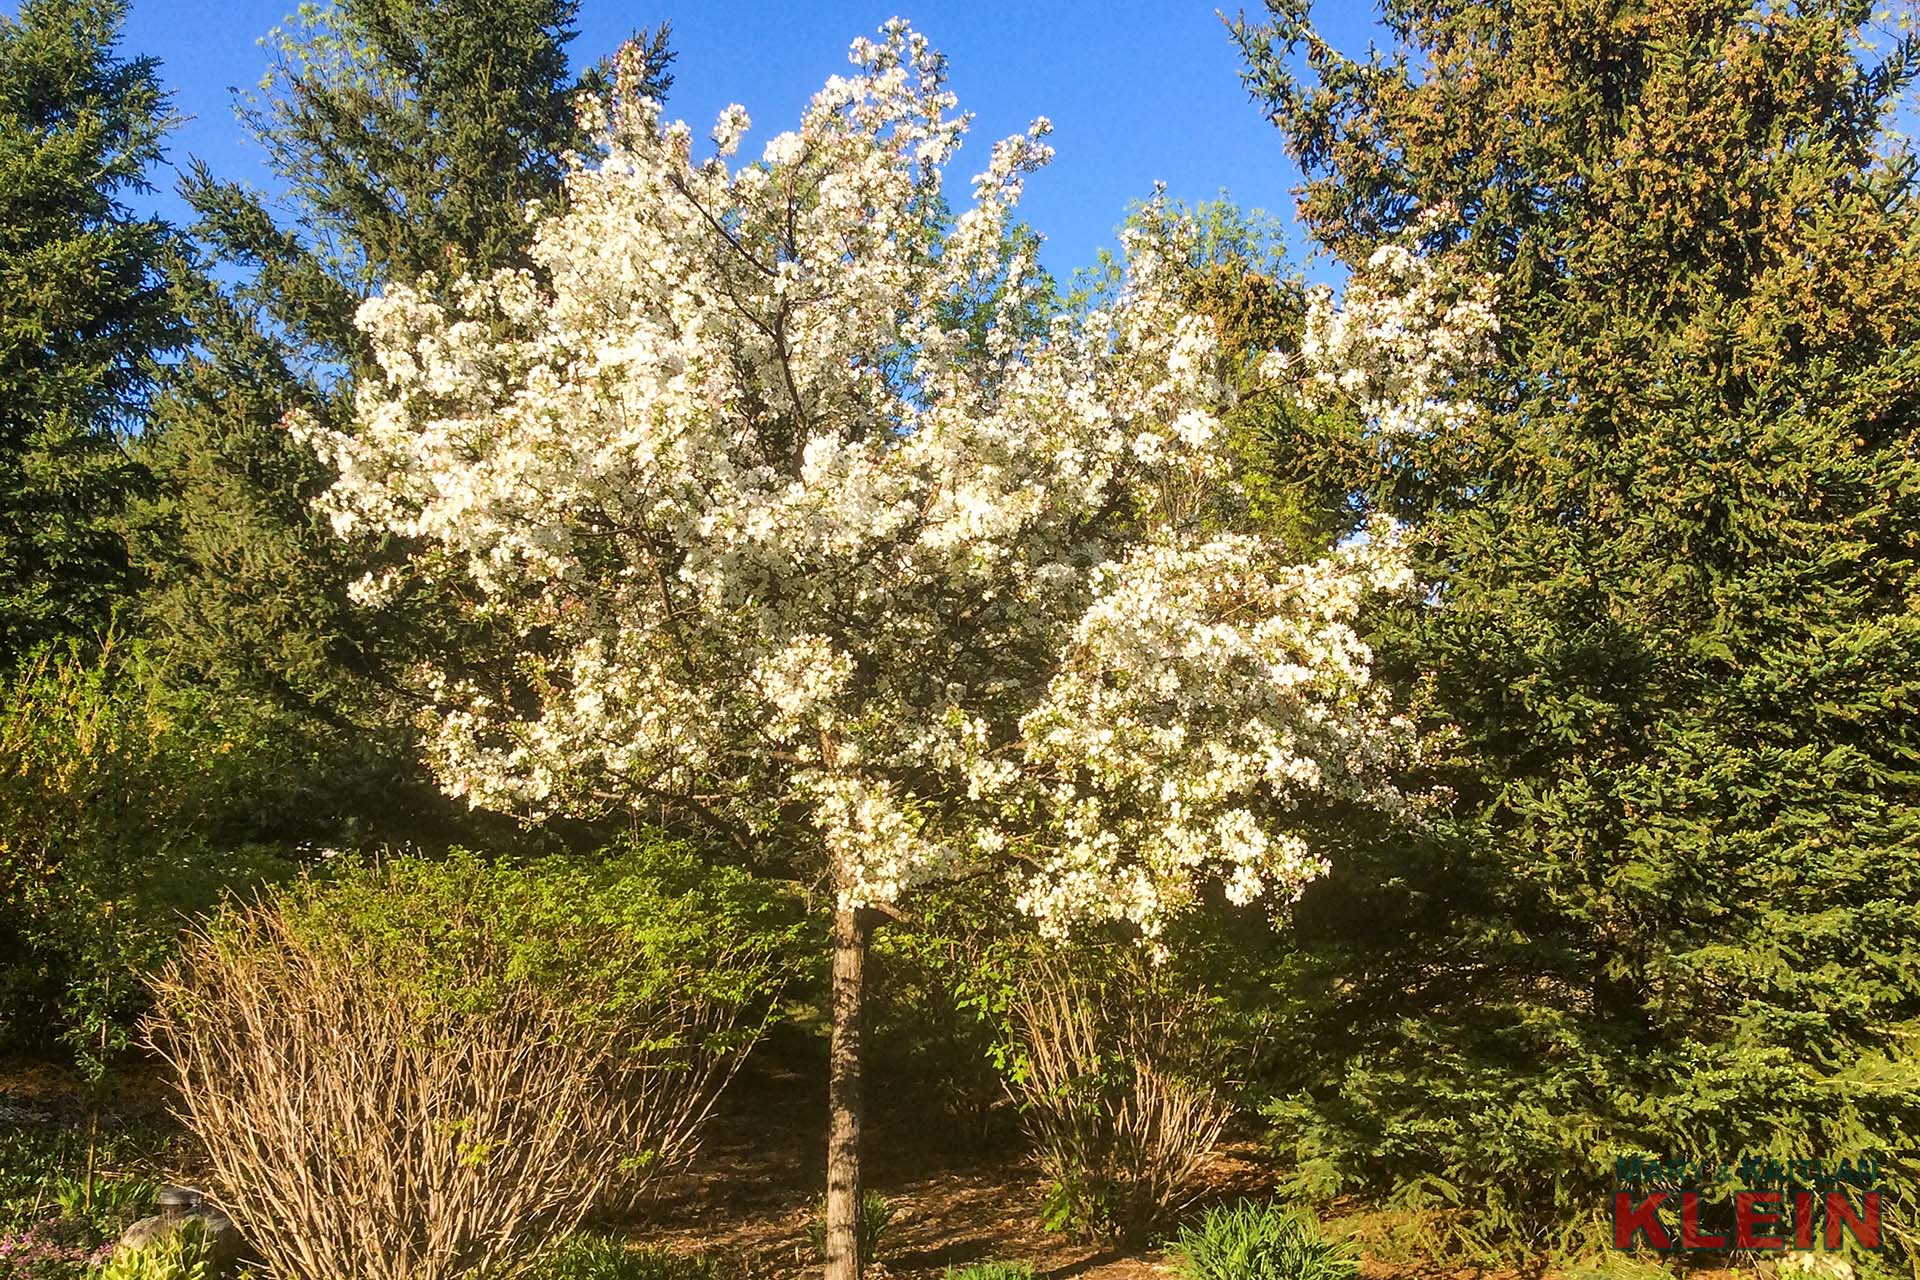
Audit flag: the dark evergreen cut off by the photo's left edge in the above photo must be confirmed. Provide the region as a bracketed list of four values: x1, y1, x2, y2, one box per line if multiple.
[0, 0, 179, 670]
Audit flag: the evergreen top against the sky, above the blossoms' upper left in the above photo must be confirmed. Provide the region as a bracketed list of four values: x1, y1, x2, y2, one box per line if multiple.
[237, 0, 672, 288]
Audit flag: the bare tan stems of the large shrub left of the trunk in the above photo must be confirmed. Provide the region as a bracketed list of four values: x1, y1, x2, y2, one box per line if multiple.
[150, 906, 626, 1280]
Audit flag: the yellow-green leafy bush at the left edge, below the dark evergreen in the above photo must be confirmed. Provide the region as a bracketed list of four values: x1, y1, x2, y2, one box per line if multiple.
[0, 639, 301, 1075]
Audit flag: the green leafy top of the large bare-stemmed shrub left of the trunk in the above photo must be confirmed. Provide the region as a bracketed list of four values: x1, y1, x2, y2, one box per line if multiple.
[278, 837, 814, 1201]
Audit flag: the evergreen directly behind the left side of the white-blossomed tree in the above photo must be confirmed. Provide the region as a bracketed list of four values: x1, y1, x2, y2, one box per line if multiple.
[123, 0, 670, 840]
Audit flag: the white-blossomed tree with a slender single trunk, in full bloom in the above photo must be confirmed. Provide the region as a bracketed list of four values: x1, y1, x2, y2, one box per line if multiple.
[295, 23, 1482, 1280]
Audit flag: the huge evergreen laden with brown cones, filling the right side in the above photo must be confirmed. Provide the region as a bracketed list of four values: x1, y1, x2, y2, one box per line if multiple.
[1236, 0, 1920, 1226]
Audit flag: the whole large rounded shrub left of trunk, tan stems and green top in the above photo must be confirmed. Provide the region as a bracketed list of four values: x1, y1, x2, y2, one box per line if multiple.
[152, 844, 799, 1280]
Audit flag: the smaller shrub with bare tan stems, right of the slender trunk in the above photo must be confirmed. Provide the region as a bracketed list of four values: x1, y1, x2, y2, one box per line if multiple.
[1012, 950, 1233, 1242]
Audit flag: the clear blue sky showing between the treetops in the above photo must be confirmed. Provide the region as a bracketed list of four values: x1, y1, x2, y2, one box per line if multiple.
[86, 0, 1369, 276]
